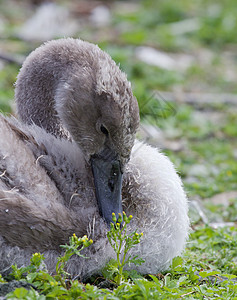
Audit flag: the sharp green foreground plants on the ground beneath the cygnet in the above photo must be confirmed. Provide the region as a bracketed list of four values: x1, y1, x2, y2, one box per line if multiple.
[2, 226, 237, 300]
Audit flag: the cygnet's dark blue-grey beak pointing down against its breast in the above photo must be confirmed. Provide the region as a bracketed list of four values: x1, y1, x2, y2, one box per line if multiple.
[91, 148, 122, 225]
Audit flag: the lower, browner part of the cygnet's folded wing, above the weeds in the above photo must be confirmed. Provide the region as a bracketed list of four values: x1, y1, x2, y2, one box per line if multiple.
[0, 187, 77, 251]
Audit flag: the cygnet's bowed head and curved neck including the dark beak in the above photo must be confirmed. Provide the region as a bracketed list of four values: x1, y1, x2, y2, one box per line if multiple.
[16, 39, 139, 223]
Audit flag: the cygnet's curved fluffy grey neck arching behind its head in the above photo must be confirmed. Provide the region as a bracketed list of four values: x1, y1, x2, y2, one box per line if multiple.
[15, 39, 100, 136]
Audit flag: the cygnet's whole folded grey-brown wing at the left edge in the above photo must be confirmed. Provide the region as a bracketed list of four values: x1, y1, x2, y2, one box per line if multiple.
[0, 116, 86, 249]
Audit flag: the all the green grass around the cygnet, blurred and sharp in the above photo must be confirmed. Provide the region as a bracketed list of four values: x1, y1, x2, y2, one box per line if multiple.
[0, 0, 237, 300]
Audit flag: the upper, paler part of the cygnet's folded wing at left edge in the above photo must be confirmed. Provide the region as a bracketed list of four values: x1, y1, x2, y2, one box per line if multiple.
[0, 116, 63, 205]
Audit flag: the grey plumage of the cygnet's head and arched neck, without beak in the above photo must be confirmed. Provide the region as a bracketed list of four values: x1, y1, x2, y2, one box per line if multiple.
[16, 39, 139, 164]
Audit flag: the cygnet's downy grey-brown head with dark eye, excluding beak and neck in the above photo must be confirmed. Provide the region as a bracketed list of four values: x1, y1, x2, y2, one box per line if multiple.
[55, 49, 139, 168]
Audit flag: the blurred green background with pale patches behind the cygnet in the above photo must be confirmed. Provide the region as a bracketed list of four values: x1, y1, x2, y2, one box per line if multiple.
[0, 0, 237, 222]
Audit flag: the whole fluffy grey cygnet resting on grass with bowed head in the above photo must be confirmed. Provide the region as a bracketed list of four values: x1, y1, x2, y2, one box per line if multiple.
[0, 39, 189, 277]
